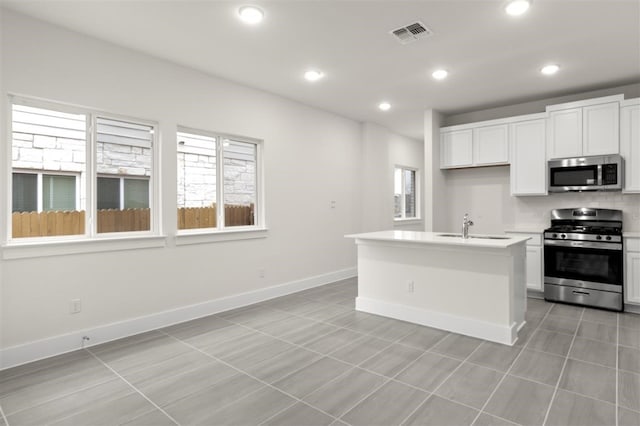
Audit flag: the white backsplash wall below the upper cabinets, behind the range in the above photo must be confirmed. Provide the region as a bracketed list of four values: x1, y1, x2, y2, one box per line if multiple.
[445, 166, 640, 234]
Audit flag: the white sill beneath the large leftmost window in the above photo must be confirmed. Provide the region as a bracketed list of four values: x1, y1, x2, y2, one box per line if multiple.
[2, 235, 167, 260]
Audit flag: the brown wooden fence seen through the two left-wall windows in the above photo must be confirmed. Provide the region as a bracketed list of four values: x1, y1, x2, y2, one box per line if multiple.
[12, 204, 255, 238]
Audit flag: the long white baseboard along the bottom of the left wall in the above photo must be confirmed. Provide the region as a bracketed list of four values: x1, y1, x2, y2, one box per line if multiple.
[0, 267, 357, 370]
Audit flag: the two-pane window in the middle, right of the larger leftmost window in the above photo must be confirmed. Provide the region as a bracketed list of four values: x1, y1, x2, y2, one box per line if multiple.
[177, 130, 260, 229]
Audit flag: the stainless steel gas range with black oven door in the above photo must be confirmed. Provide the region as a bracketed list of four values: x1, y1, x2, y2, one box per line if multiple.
[544, 208, 624, 311]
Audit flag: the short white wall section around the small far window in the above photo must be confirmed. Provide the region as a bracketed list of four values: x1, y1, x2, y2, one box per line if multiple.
[362, 123, 424, 232]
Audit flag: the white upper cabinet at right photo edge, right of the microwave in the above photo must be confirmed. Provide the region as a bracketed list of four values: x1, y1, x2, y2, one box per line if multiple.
[620, 98, 640, 193]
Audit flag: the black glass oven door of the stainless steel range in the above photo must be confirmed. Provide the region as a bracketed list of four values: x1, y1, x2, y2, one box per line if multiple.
[544, 241, 624, 286]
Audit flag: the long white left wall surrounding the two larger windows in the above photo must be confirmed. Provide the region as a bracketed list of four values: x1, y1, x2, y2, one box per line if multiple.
[0, 10, 372, 360]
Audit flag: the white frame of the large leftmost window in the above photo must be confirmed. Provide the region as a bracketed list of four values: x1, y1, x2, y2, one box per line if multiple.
[3, 94, 160, 245]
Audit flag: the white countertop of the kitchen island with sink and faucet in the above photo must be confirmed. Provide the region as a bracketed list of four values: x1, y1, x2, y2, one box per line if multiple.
[345, 230, 529, 248]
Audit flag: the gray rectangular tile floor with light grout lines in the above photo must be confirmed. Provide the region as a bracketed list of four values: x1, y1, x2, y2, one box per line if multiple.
[0, 279, 640, 426]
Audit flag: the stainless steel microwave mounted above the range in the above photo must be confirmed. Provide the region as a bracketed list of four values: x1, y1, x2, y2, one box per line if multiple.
[548, 155, 623, 192]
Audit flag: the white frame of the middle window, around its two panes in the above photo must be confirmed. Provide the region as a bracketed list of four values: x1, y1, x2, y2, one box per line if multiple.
[175, 125, 266, 238]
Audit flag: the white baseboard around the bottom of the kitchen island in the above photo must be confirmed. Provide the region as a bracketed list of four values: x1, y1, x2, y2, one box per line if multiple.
[356, 297, 521, 345]
